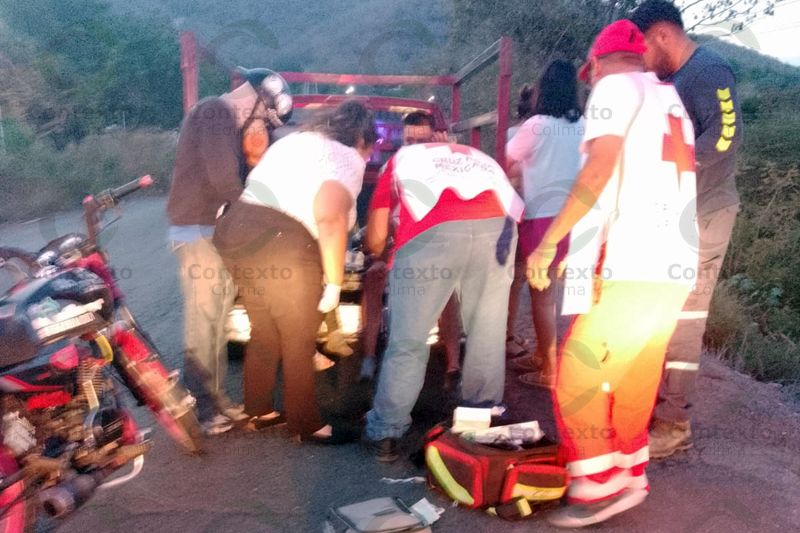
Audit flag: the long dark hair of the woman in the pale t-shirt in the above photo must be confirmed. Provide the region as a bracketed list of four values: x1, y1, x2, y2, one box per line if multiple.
[533, 59, 581, 122]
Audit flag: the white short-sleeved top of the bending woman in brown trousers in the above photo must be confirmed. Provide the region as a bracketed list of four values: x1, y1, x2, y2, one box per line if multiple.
[241, 132, 366, 238]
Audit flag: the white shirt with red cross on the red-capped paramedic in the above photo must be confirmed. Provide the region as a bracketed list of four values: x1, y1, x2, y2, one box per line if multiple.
[565, 72, 698, 313]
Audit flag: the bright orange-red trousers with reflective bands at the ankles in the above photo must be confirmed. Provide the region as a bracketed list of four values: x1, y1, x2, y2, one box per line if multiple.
[553, 281, 689, 503]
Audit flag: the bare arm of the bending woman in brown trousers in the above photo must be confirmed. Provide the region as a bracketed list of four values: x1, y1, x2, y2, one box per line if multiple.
[314, 180, 353, 287]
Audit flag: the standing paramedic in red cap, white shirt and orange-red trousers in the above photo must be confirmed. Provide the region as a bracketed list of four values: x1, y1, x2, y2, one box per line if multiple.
[528, 20, 697, 527]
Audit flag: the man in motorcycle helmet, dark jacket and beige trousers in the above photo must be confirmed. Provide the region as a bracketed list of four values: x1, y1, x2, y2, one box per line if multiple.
[167, 69, 292, 435]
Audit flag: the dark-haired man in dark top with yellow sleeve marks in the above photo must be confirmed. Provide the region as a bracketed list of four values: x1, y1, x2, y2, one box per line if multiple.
[630, 0, 742, 459]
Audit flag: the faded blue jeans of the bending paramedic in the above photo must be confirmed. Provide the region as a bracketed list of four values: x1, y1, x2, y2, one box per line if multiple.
[366, 218, 517, 440]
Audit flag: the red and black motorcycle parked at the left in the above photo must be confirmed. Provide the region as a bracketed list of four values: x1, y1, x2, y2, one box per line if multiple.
[0, 176, 202, 533]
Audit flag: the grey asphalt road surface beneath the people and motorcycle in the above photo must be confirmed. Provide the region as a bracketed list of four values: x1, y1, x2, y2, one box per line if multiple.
[0, 198, 800, 533]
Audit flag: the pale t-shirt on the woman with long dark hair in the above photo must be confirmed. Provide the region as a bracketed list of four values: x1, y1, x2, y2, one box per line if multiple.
[506, 115, 586, 220]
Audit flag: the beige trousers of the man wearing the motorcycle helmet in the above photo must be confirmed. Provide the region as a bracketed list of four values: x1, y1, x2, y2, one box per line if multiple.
[172, 237, 235, 422]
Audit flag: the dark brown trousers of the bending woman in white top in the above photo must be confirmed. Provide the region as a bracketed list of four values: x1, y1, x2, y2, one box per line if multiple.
[214, 201, 324, 436]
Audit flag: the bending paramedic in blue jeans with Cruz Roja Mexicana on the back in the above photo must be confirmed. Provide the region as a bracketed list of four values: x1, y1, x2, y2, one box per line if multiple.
[364, 143, 524, 462]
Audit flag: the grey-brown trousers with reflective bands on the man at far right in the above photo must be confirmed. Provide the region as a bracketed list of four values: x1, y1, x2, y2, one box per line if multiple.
[653, 204, 739, 422]
